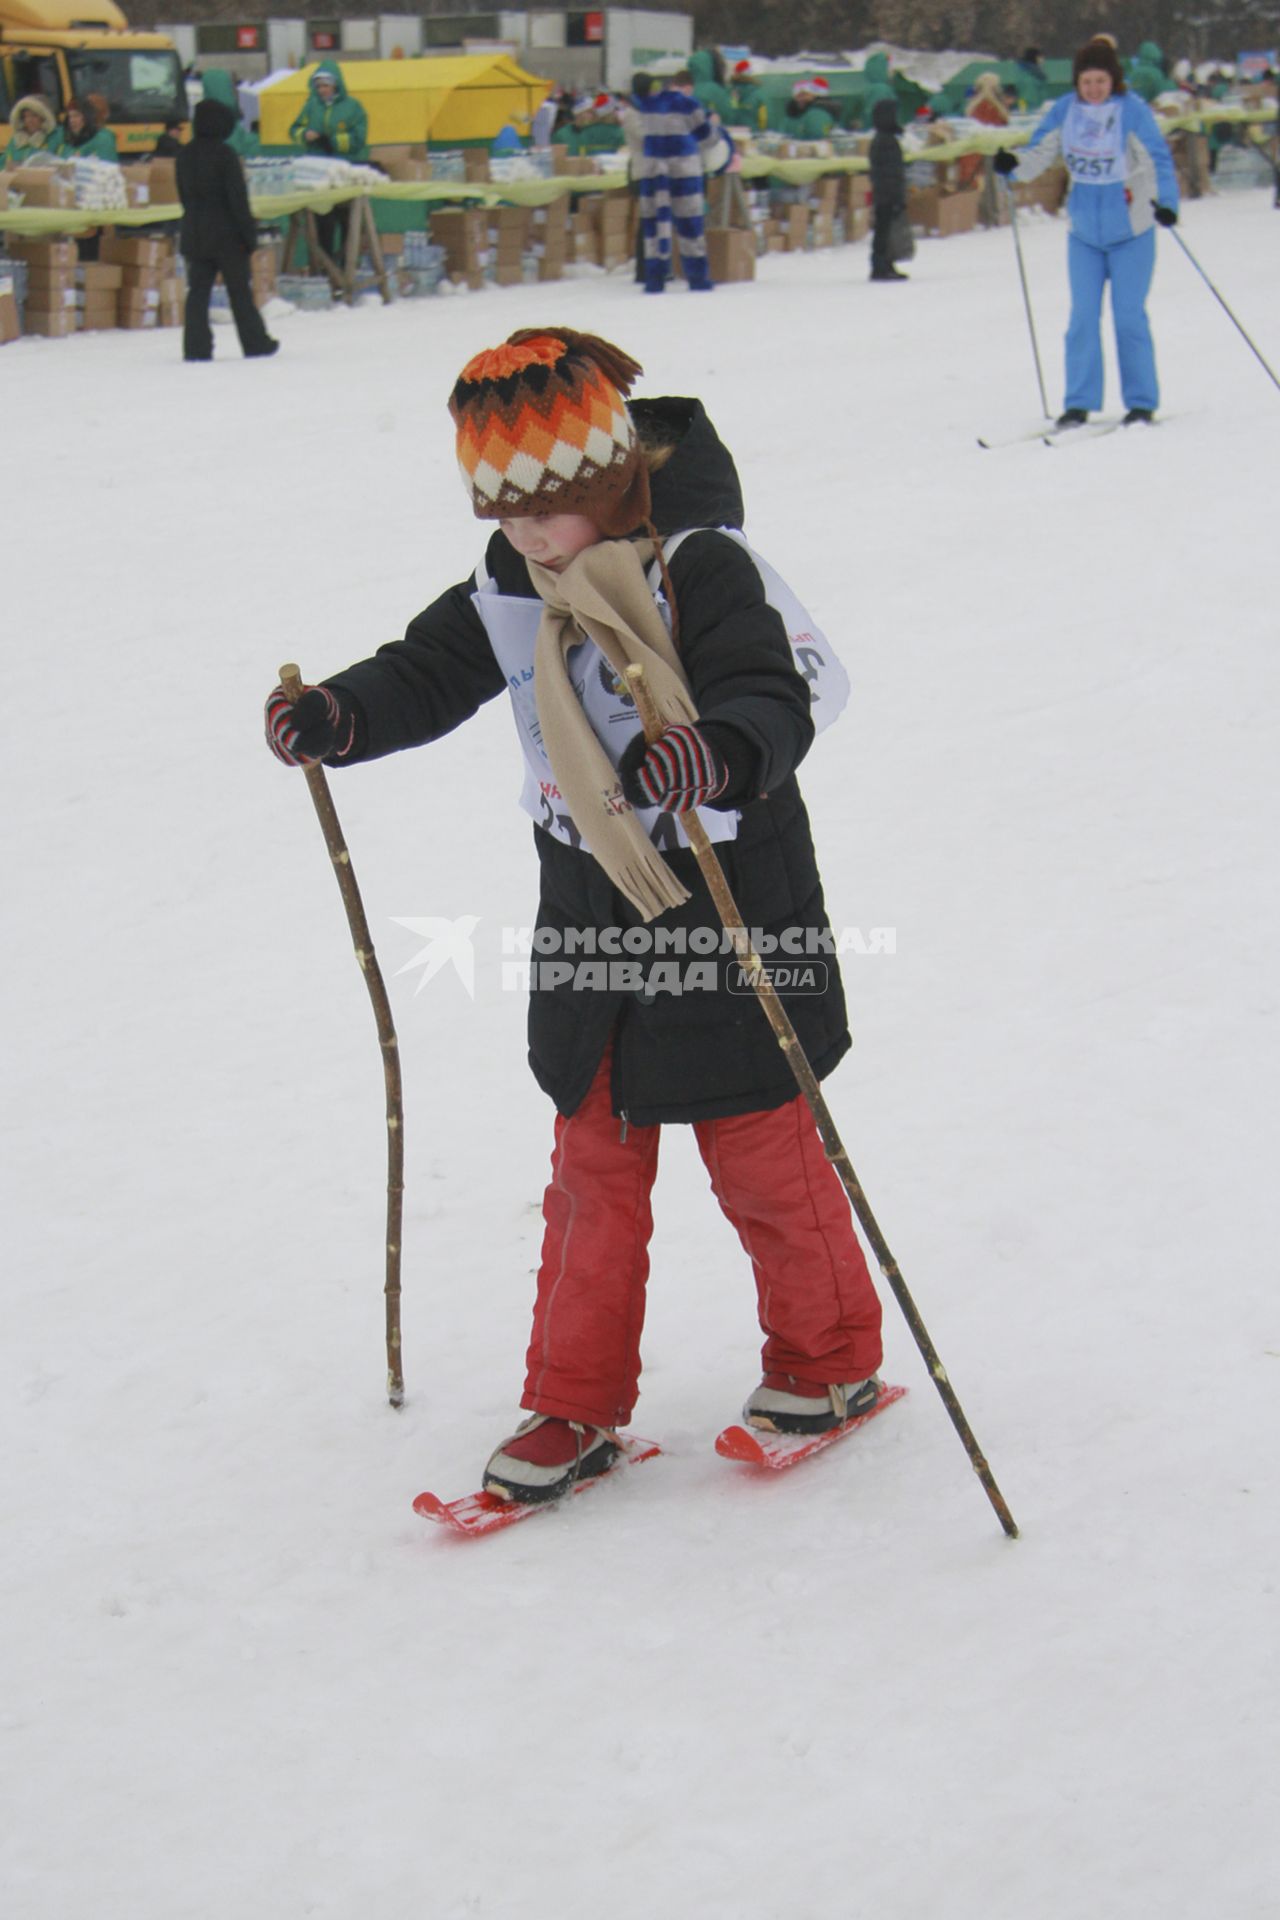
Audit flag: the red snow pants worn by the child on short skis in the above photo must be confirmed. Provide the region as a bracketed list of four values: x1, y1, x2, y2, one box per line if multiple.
[520, 1048, 881, 1427]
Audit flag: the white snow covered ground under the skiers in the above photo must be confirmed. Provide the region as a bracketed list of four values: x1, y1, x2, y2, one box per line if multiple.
[0, 192, 1280, 1920]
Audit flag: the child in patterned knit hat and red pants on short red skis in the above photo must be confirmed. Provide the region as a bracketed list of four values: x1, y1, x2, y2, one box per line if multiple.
[267, 328, 881, 1501]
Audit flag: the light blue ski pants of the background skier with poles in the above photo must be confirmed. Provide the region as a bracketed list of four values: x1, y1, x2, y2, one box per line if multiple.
[1063, 227, 1159, 413]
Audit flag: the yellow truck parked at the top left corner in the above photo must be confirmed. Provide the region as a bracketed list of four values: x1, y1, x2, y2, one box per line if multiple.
[0, 0, 188, 159]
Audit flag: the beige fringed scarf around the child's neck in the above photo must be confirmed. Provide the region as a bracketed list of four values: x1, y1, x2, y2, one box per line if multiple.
[528, 540, 699, 920]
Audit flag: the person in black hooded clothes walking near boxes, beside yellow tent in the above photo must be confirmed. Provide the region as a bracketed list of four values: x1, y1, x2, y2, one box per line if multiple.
[177, 100, 280, 359]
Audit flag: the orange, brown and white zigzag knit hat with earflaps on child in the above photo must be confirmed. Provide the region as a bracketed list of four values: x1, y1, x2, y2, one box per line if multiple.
[449, 326, 649, 538]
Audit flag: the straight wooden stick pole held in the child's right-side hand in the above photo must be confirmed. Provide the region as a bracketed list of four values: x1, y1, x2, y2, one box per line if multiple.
[626, 666, 1017, 1540]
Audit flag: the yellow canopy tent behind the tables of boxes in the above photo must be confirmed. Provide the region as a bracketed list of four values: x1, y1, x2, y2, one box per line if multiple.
[259, 54, 551, 146]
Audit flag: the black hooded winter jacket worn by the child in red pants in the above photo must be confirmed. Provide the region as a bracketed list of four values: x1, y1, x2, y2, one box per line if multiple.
[328, 399, 850, 1125]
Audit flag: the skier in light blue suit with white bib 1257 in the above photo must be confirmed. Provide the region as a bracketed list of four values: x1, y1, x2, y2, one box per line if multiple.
[994, 35, 1178, 426]
